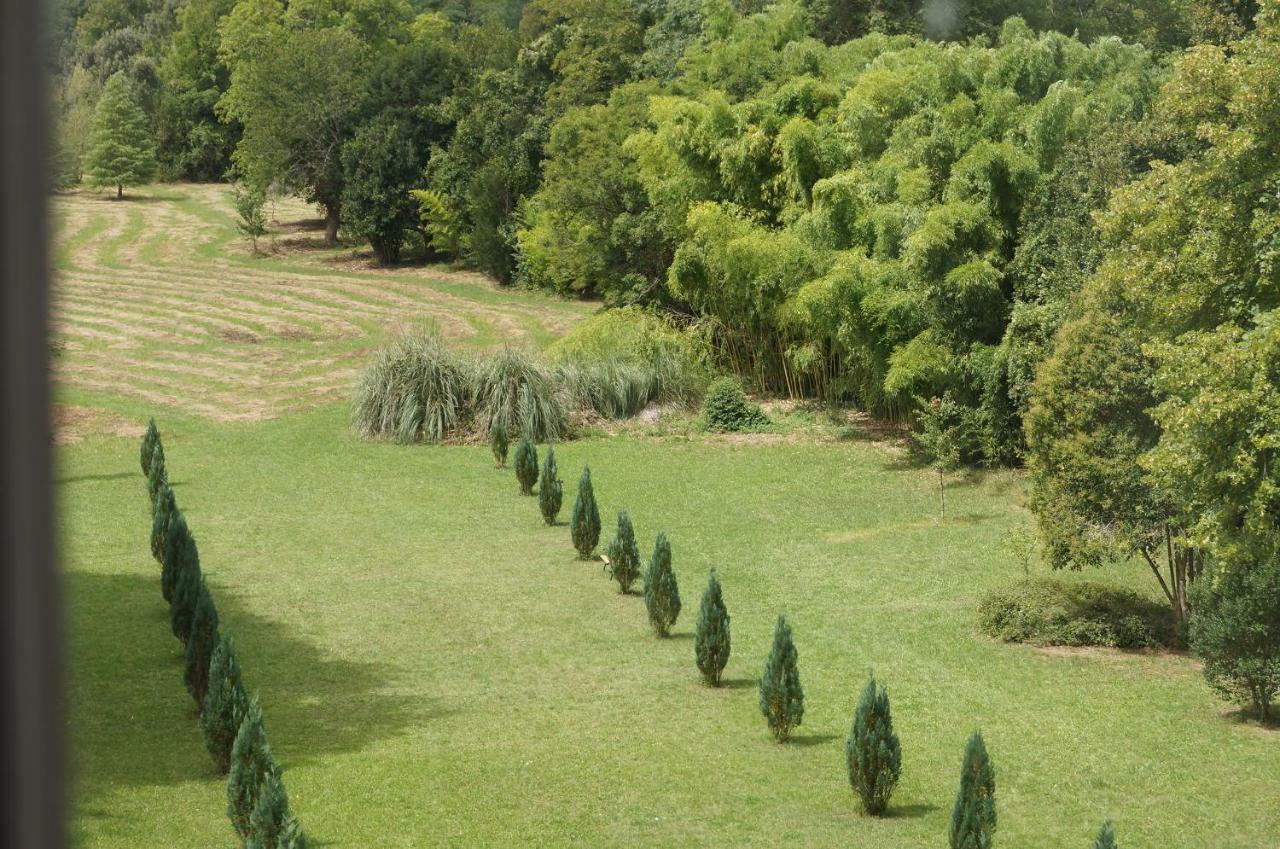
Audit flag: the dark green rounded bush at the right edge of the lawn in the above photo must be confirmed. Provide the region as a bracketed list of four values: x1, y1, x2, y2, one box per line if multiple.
[1190, 548, 1280, 722]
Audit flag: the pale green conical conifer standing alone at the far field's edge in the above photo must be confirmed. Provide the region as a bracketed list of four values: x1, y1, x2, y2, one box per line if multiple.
[84, 70, 156, 200]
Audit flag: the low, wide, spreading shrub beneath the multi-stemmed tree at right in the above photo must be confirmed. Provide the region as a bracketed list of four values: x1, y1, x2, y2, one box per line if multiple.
[978, 578, 1175, 648]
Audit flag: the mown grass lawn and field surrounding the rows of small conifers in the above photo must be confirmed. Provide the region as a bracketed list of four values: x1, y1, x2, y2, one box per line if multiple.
[55, 187, 1280, 849]
